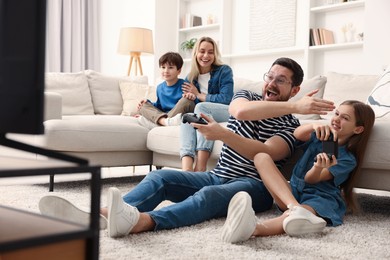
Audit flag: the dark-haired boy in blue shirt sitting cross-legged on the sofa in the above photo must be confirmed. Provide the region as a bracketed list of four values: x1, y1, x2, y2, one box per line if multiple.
[137, 52, 195, 128]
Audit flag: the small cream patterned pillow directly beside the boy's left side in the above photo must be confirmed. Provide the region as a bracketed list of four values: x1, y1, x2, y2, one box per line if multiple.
[119, 81, 156, 116]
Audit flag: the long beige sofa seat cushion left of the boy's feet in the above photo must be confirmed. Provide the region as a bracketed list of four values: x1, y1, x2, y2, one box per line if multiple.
[44, 115, 148, 152]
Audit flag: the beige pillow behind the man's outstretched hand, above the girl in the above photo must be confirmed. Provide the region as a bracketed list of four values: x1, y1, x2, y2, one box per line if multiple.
[289, 75, 327, 120]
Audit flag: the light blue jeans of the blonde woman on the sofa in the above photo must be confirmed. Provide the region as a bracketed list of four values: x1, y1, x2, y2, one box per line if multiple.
[180, 102, 229, 158]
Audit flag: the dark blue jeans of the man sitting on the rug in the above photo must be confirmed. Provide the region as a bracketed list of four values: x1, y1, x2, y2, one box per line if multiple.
[123, 169, 273, 230]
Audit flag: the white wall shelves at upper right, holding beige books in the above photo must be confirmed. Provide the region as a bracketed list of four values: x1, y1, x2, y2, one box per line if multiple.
[307, 0, 365, 76]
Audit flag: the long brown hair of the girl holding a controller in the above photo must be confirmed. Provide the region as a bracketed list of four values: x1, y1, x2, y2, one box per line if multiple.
[341, 100, 375, 212]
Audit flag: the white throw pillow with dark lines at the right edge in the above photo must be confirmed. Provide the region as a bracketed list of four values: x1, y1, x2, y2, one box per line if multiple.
[367, 66, 390, 118]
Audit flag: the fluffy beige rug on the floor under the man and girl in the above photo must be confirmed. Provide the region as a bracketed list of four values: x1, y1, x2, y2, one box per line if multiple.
[0, 178, 390, 260]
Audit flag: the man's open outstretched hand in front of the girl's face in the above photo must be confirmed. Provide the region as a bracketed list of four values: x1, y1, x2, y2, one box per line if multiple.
[295, 89, 336, 115]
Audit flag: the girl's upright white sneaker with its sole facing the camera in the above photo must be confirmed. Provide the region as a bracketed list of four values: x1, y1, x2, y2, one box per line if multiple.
[222, 191, 257, 243]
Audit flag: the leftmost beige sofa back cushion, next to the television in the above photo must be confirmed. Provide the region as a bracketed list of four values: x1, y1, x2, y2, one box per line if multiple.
[45, 72, 94, 115]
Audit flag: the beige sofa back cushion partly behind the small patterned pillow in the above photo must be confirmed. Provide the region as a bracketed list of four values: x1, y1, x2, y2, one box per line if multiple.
[85, 70, 148, 115]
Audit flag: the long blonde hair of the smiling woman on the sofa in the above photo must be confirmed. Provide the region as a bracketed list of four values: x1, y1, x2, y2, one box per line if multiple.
[187, 36, 223, 82]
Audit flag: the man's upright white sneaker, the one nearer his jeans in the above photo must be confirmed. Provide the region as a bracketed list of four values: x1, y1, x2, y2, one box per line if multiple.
[107, 187, 140, 237]
